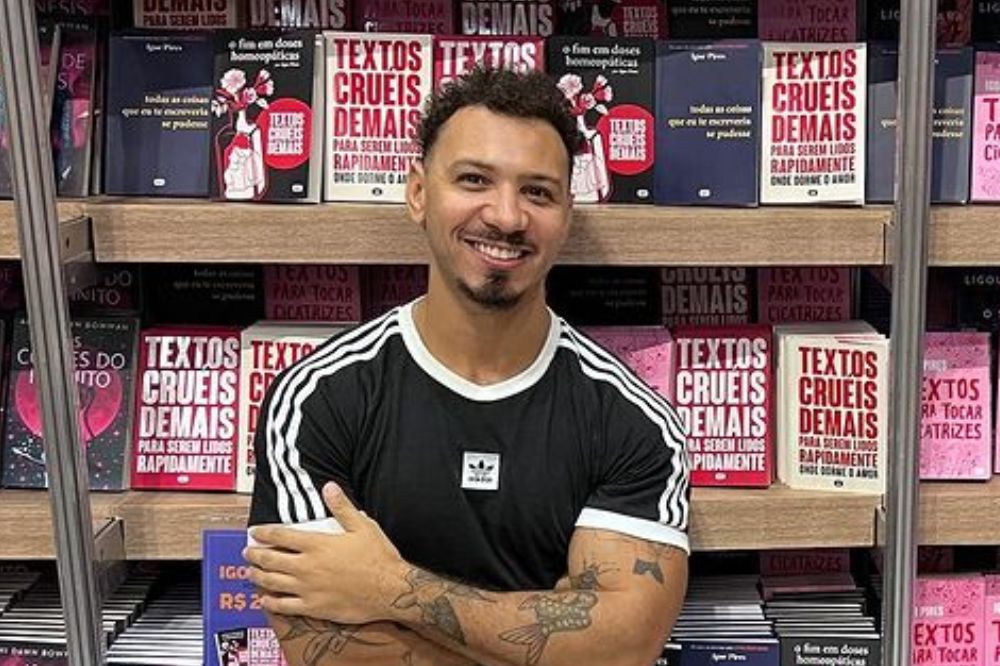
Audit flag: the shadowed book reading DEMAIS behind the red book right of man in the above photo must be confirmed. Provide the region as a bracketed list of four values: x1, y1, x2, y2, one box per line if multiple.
[660, 267, 753, 327]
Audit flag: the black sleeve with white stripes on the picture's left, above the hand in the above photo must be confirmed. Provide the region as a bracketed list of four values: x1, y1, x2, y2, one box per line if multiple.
[248, 363, 353, 526]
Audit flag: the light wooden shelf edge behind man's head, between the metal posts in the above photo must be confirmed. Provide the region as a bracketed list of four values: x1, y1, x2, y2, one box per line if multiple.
[86, 199, 891, 266]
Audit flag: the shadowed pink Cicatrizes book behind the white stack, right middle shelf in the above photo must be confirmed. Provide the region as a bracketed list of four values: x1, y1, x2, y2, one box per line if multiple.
[757, 266, 851, 324]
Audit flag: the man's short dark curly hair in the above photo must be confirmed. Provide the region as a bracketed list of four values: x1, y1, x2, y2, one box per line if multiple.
[417, 66, 583, 172]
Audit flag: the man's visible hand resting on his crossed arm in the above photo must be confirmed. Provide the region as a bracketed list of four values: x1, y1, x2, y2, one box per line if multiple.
[244, 483, 410, 625]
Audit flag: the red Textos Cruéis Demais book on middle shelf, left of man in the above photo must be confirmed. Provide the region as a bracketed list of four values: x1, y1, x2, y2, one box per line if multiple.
[132, 327, 240, 491]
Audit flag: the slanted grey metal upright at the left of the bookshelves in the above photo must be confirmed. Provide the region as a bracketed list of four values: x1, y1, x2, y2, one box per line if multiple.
[0, 0, 104, 666]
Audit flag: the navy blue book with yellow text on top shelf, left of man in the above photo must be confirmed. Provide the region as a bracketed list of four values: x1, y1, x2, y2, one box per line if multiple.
[104, 31, 213, 197]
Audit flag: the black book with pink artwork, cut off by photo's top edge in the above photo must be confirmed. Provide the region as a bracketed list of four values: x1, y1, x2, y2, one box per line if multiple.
[557, 0, 667, 39]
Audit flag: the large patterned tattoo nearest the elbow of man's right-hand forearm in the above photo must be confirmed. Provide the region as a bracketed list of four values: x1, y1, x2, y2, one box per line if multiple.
[500, 590, 597, 666]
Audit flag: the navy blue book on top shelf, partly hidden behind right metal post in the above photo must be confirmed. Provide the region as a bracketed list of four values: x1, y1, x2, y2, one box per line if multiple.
[865, 44, 975, 203]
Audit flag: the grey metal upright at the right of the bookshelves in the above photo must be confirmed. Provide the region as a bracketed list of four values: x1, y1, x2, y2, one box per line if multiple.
[882, 0, 936, 666]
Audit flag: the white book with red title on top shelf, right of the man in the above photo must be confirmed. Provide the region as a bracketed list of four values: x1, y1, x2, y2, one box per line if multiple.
[760, 42, 867, 204]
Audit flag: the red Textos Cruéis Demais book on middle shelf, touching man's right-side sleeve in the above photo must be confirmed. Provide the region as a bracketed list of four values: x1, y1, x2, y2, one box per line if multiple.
[674, 325, 774, 487]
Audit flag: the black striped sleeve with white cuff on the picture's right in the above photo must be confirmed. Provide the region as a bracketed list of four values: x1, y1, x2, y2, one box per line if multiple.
[576, 396, 690, 552]
